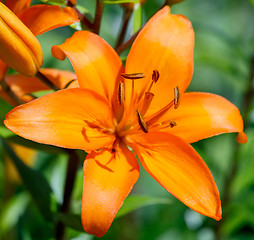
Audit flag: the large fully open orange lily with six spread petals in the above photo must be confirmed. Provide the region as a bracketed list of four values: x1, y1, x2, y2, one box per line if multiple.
[4, 7, 247, 237]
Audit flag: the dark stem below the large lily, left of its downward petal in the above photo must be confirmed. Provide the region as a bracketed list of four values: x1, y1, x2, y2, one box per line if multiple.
[56, 149, 79, 240]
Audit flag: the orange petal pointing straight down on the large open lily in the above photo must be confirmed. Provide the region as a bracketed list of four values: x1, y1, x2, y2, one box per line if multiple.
[81, 145, 139, 237]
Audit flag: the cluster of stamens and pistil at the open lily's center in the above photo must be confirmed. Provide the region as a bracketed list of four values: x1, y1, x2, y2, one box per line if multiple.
[116, 70, 180, 137]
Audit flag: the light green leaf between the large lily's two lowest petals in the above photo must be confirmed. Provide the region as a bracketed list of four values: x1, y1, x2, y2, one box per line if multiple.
[116, 196, 171, 218]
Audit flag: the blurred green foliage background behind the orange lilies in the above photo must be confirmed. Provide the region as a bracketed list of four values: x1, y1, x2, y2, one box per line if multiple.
[0, 0, 254, 240]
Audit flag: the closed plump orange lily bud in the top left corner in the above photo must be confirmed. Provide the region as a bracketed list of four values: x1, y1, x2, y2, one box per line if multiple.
[0, 2, 43, 76]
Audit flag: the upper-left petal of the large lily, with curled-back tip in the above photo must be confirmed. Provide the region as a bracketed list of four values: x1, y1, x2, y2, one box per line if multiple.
[52, 31, 122, 99]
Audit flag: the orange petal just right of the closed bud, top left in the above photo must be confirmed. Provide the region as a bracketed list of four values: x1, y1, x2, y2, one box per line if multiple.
[19, 5, 79, 35]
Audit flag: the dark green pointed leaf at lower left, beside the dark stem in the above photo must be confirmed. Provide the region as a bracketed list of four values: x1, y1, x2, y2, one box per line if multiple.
[2, 139, 56, 220]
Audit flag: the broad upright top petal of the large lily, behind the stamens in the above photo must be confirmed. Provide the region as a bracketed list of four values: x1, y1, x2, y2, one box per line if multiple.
[126, 7, 194, 114]
